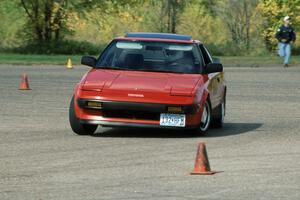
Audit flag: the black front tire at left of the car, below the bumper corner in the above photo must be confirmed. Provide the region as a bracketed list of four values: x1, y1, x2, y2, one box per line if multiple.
[69, 96, 98, 135]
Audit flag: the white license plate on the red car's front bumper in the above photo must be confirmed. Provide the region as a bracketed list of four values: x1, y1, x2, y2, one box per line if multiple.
[160, 113, 185, 127]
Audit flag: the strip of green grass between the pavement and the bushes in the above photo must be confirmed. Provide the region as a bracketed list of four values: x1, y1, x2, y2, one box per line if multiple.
[0, 53, 300, 67]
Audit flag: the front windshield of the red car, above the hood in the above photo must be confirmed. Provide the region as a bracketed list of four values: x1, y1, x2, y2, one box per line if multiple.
[97, 40, 202, 74]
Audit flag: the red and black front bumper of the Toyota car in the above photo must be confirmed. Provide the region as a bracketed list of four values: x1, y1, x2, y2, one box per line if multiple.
[75, 98, 202, 129]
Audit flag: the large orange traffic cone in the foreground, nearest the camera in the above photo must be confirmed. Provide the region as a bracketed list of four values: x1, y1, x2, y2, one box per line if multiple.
[191, 143, 216, 175]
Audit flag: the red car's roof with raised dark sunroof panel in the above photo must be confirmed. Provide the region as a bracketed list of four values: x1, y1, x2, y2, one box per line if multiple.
[115, 32, 199, 43]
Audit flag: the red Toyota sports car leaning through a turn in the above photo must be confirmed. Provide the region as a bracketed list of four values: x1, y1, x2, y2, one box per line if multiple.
[69, 33, 226, 135]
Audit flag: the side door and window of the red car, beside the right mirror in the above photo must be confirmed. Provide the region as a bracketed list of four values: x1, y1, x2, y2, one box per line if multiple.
[199, 44, 223, 108]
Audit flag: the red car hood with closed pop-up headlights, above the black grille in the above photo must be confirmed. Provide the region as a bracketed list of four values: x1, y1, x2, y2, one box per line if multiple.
[82, 69, 203, 96]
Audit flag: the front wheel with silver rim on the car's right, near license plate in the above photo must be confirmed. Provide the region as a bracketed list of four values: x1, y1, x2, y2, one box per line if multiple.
[195, 99, 212, 135]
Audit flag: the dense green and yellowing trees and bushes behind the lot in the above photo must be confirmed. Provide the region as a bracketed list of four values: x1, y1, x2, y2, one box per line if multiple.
[0, 0, 300, 55]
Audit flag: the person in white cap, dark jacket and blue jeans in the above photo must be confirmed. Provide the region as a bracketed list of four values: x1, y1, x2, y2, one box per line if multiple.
[275, 16, 296, 67]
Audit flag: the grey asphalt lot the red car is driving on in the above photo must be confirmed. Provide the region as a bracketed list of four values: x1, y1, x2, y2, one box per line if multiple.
[0, 65, 300, 200]
